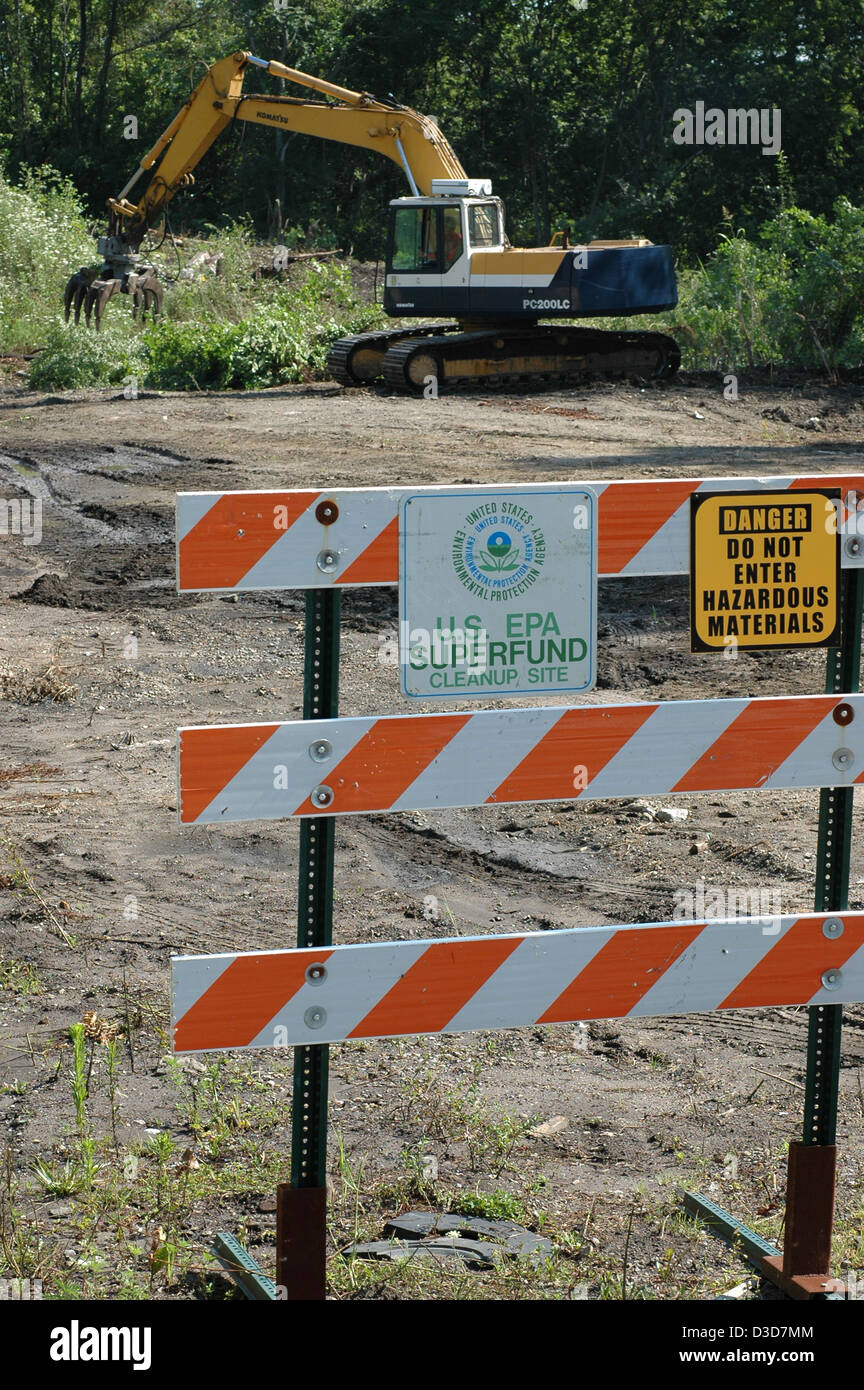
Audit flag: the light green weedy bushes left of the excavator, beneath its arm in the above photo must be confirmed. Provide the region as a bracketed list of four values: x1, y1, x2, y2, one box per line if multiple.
[10, 190, 386, 391]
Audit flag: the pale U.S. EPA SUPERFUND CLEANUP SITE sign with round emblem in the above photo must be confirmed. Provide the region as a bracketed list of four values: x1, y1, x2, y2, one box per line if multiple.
[399, 485, 597, 699]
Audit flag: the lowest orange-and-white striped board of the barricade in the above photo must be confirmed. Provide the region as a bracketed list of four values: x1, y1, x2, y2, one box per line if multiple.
[174, 912, 864, 1052]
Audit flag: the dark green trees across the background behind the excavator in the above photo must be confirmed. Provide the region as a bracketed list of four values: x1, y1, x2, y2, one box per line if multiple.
[0, 0, 864, 260]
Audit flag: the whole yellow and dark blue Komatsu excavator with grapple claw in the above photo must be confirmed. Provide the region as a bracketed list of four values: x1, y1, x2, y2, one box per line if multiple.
[65, 53, 679, 391]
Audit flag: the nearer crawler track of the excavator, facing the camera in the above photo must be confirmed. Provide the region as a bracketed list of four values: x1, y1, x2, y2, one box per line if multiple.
[382, 324, 681, 392]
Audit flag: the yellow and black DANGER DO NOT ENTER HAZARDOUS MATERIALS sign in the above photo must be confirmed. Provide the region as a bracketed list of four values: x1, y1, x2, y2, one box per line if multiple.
[690, 488, 840, 652]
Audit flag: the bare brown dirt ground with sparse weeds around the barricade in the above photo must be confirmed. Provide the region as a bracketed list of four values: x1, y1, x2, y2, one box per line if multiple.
[0, 375, 864, 1298]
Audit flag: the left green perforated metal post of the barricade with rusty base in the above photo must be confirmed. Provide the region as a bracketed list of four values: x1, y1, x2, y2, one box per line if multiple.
[276, 588, 342, 1300]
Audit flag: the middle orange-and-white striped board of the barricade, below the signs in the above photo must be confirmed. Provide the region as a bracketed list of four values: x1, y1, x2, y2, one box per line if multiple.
[179, 695, 864, 824]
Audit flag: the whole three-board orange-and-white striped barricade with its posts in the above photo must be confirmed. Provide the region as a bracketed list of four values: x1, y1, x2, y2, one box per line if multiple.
[174, 473, 864, 1297]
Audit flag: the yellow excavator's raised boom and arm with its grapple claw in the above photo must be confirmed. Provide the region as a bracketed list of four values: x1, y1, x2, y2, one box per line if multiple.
[65, 53, 465, 327]
